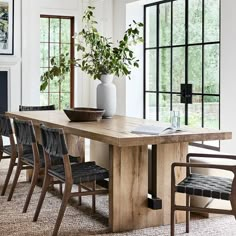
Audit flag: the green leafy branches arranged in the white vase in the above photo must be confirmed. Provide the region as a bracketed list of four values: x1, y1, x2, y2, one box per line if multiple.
[40, 6, 143, 90]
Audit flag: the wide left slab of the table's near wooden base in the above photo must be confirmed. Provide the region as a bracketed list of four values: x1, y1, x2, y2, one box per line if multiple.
[109, 146, 157, 232]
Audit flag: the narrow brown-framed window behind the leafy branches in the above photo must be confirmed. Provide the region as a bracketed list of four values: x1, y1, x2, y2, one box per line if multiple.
[40, 15, 74, 109]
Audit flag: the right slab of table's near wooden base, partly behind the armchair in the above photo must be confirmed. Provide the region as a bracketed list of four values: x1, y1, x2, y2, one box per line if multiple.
[152, 143, 188, 225]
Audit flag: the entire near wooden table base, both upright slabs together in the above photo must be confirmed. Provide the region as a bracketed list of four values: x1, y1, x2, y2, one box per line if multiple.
[109, 143, 188, 232]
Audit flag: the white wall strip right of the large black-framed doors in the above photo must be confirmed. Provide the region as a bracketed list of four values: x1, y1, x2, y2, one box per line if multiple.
[220, 0, 236, 153]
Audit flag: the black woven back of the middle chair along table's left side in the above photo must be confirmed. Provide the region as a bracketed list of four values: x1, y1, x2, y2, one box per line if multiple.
[14, 118, 36, 145]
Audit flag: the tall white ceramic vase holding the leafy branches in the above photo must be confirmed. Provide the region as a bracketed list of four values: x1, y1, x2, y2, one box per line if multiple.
[97, 75, 116, 118]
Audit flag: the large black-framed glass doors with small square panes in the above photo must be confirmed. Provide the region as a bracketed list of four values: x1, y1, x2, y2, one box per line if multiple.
[144, 0, 220, 149]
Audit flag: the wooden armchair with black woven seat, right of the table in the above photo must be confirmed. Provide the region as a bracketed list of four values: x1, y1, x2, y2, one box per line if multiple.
[171, 153, 236, 236]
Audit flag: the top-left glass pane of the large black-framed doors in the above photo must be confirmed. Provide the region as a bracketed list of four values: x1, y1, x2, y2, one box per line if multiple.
[146, 6, 157, 47]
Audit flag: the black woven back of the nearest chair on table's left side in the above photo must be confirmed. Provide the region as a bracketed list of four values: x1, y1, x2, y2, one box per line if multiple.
[40, 124, 68, 157]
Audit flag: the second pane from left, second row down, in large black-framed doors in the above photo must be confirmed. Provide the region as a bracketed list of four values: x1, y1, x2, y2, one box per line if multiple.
[159, 48, 171, 92]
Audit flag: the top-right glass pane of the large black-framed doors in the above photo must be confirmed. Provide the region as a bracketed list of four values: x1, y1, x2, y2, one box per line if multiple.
[204, 0, 220, 42]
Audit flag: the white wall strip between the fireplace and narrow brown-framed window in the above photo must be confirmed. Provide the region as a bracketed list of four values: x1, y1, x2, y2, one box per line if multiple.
[21, 0, 40, 105]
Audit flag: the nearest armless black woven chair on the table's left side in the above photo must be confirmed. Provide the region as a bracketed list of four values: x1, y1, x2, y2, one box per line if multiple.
[33, 125, 109, 236]
